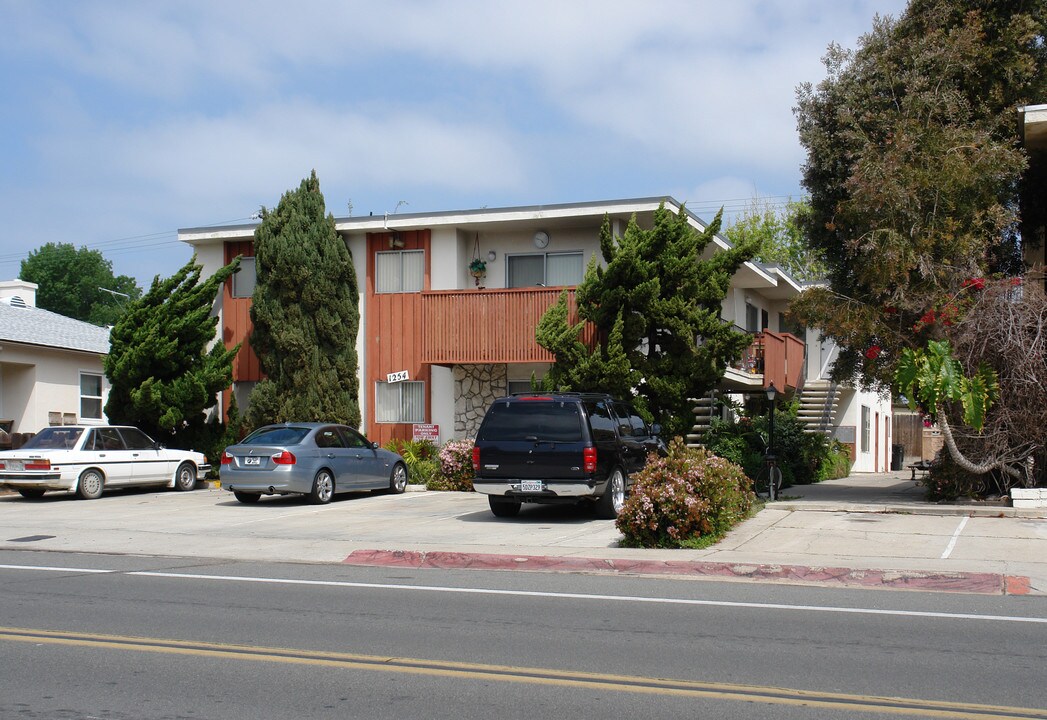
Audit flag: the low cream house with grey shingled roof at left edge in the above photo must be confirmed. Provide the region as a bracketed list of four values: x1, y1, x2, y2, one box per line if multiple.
[0, 280, 109, 433]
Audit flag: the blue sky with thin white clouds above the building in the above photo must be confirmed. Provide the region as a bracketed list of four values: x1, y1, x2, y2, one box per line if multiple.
[0, 0, 906, 287]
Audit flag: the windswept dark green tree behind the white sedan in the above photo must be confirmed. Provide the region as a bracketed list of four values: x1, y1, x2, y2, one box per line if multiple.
[105, 257, 240, 457]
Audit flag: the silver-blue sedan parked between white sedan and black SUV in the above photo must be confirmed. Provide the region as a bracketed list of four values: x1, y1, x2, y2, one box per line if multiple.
[219, 423, 407, 504]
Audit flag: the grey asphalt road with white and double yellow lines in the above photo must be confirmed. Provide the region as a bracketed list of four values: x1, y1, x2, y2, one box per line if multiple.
[0, 550, 1047, 720]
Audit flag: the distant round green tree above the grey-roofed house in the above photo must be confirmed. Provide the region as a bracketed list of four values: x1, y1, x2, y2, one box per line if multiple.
[19, 243, 141, 325]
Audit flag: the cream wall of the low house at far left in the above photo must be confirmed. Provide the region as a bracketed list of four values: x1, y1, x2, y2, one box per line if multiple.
[0, 343, 109, 432]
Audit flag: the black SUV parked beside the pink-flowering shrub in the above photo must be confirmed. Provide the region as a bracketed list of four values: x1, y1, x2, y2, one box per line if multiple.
[472, 392, 665, 518]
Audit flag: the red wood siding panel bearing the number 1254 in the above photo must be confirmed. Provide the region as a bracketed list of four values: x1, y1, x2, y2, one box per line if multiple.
[360, 230, 432, 445]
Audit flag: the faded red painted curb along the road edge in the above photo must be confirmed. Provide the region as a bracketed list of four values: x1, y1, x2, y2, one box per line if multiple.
[342, 550, 1013, 594]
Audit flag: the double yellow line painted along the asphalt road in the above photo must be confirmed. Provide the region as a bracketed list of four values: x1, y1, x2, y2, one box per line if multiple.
[0, 627, 1047, 720]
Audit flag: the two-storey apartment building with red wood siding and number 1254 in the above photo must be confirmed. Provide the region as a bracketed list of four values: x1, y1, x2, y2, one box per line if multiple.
[178, 198, 890, 470]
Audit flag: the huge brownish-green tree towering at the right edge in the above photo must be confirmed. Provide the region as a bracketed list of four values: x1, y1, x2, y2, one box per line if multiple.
[793, 0, 1047, 483]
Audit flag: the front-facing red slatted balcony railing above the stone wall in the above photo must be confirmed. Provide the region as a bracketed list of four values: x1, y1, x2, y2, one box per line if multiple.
[422, 288, 594, 365]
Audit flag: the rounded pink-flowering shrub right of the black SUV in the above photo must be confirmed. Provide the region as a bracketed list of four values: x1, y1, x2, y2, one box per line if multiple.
[616, 437, 754, 547]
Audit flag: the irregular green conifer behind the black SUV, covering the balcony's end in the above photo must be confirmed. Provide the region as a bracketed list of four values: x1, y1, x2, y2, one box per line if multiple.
[536, 204, 756, 435]
